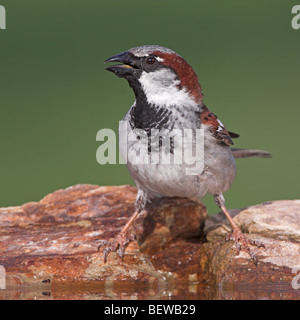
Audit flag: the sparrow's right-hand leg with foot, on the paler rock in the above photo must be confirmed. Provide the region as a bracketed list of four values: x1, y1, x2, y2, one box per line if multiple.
[214, 194, 264, 265]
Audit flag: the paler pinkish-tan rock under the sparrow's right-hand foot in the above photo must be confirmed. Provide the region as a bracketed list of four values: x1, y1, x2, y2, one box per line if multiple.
[204, 200, 300, 284]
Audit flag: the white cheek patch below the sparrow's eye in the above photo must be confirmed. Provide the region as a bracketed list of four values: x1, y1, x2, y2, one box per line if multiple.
[139, 69, 196, 107]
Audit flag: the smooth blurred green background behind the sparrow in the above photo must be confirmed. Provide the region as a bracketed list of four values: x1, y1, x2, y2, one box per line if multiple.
[0, 0, 300, 213]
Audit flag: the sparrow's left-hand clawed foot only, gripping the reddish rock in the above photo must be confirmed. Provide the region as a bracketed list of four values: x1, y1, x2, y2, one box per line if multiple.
[98, 233, 135, 263]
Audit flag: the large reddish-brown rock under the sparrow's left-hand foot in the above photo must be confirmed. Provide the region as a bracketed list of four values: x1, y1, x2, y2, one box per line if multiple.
[0, 185, 206, 285]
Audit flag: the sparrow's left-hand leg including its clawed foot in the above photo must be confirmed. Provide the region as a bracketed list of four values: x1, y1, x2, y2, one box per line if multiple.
[98, 195, 146, 263]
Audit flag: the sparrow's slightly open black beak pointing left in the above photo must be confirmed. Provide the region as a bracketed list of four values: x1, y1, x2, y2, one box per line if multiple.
[104, 51, 135, 78]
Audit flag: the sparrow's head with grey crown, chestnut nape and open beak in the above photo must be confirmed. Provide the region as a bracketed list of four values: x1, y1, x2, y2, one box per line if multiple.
[105, 45, 203, 106]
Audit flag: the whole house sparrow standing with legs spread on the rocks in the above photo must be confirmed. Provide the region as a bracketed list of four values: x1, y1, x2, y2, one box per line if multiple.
[100, 45, 270, 263]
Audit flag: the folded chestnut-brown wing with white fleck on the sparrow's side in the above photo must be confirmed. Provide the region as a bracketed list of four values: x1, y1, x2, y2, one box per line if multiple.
[200, 105, 238, 146]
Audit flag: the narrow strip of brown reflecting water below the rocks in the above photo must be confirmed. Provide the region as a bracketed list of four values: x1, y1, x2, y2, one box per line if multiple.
[0, 282, 300, 300]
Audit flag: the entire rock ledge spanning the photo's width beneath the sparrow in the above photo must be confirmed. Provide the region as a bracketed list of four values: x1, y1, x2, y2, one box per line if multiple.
[0, 185, 300, 288]
